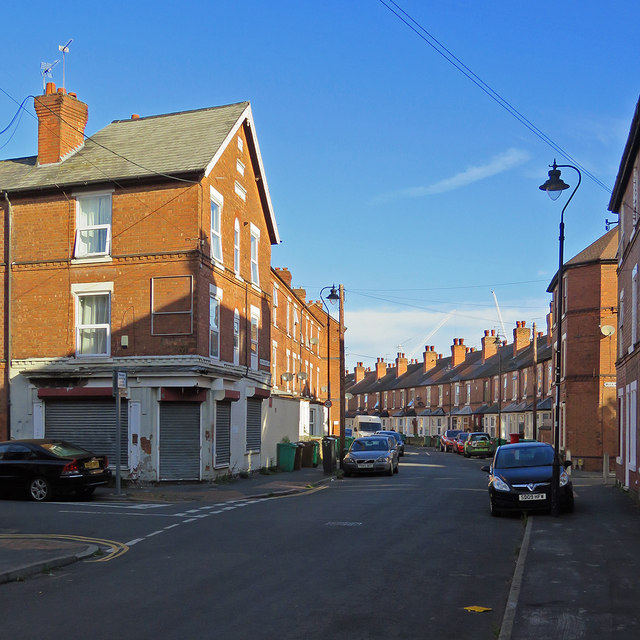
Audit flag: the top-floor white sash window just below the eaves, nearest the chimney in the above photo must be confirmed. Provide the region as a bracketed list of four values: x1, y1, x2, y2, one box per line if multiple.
[74, 193, 111, 258]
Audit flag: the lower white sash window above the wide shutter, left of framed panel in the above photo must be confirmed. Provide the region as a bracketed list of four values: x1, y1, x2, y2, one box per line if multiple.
[71, 283, 113, 356]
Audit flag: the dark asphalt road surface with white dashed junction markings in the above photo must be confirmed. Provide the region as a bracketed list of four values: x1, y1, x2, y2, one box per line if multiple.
[0, 450, 524, 640]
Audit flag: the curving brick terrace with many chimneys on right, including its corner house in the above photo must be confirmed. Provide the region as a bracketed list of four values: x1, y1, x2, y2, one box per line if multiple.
[347, 228, 618, 469]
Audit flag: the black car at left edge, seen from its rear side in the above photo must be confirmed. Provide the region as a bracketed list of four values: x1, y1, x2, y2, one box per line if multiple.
[0, 439, 111, 502]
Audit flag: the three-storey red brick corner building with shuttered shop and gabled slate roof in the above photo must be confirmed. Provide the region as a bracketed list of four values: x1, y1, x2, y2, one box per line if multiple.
[0, 83, 282, 480]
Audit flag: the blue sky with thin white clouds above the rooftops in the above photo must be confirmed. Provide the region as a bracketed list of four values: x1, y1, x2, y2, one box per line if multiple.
[0, 0, 640, 368]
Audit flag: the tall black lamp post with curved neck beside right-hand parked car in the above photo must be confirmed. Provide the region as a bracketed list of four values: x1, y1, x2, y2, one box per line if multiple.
[540, 160, 582, 516]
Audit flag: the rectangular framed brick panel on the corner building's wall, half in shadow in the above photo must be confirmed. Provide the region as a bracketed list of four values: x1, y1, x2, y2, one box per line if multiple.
[151, 276, 193, 336]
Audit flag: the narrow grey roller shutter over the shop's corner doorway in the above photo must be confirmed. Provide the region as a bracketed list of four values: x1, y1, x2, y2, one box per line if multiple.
[159, 402, 200, 480]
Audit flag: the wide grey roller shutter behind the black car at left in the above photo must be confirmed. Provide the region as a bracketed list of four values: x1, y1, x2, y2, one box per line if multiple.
[44, 399, 129, 468]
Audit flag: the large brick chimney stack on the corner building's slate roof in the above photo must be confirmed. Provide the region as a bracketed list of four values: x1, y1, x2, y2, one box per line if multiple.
[33, 82, 89, 165]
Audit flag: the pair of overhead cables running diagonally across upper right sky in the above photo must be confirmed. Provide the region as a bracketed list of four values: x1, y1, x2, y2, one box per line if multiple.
[379, 0, 611, 193]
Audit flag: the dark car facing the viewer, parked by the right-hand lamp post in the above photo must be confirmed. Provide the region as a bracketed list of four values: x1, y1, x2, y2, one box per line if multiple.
[482, 442, 573, 516]
